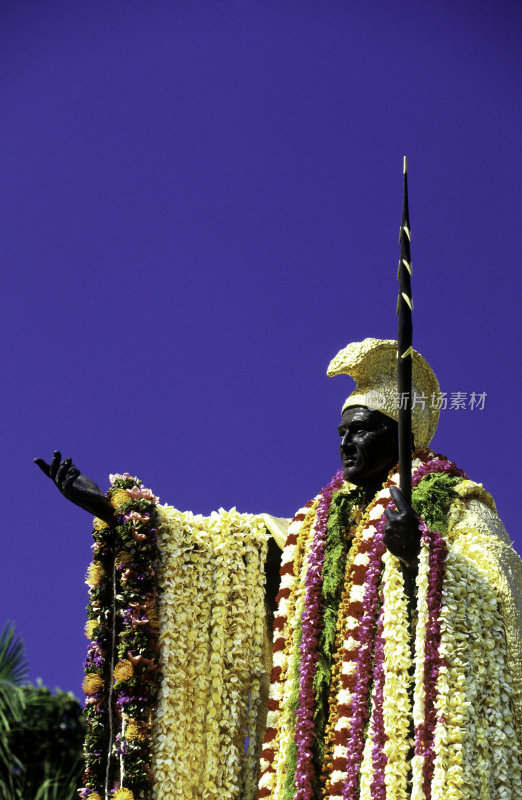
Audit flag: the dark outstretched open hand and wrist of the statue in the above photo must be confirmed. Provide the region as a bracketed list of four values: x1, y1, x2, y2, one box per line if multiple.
[34, 450, 114, 523]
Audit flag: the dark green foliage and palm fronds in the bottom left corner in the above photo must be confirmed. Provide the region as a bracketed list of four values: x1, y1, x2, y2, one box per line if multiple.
[0, 623, 83, 800]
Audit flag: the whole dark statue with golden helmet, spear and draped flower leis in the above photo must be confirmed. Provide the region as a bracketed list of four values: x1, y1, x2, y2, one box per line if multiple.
[35, 167, 522, 800]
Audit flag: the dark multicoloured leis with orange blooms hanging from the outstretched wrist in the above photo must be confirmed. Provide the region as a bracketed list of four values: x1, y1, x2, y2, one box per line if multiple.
[79, 473, 161, 800]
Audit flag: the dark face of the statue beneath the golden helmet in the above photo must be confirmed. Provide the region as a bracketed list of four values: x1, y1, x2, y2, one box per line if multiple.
[338, 406, 398, 488]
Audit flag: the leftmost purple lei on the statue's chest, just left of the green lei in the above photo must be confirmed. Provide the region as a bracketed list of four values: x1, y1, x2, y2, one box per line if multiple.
[295, 470, 344, 800]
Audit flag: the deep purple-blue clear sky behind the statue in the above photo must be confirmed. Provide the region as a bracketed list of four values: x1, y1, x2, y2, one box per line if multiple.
[0, 0, 522, 695]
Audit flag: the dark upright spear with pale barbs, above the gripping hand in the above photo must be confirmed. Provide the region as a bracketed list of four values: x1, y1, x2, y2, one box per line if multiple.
[397, 156, 413, 505]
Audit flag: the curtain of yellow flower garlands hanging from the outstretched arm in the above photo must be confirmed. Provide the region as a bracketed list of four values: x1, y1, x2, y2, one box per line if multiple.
[148, 507, 267, 800]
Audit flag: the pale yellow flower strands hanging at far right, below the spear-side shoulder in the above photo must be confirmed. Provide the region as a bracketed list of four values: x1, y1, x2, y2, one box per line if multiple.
[432, 550, 522, 800]
